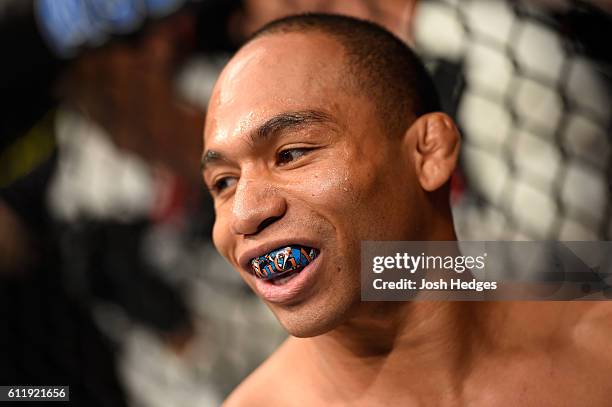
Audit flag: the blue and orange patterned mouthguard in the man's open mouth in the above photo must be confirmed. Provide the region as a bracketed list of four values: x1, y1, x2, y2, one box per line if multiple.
[249, 245, 320, 284]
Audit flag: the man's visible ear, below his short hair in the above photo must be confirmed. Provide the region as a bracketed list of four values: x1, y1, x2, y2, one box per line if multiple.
[408, 113, 461, 192]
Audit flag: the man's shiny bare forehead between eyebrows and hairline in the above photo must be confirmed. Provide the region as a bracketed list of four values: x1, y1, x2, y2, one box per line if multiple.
[204, 32, 350, 147]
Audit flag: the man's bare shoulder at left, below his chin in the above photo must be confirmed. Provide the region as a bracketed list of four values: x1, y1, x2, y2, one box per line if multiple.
[223, 337, 304, 407]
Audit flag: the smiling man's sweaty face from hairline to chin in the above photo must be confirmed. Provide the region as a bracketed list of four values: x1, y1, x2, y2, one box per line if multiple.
[204, 33, 422, 336]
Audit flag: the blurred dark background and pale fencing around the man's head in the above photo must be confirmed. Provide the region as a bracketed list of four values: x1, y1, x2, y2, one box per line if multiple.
[0, 0, 612, 407]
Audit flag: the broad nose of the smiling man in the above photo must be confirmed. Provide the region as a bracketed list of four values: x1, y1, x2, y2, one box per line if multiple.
[231, 177, 287, 235]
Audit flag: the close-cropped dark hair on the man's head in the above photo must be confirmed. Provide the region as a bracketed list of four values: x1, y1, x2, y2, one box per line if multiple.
[247, 13, 441, 134]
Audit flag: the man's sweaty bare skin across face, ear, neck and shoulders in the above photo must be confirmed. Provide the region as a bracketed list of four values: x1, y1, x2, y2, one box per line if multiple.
[203, 32, 612, 406]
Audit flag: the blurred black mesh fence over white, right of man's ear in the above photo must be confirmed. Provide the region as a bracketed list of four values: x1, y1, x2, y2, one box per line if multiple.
[416, 0, 612, 240]
